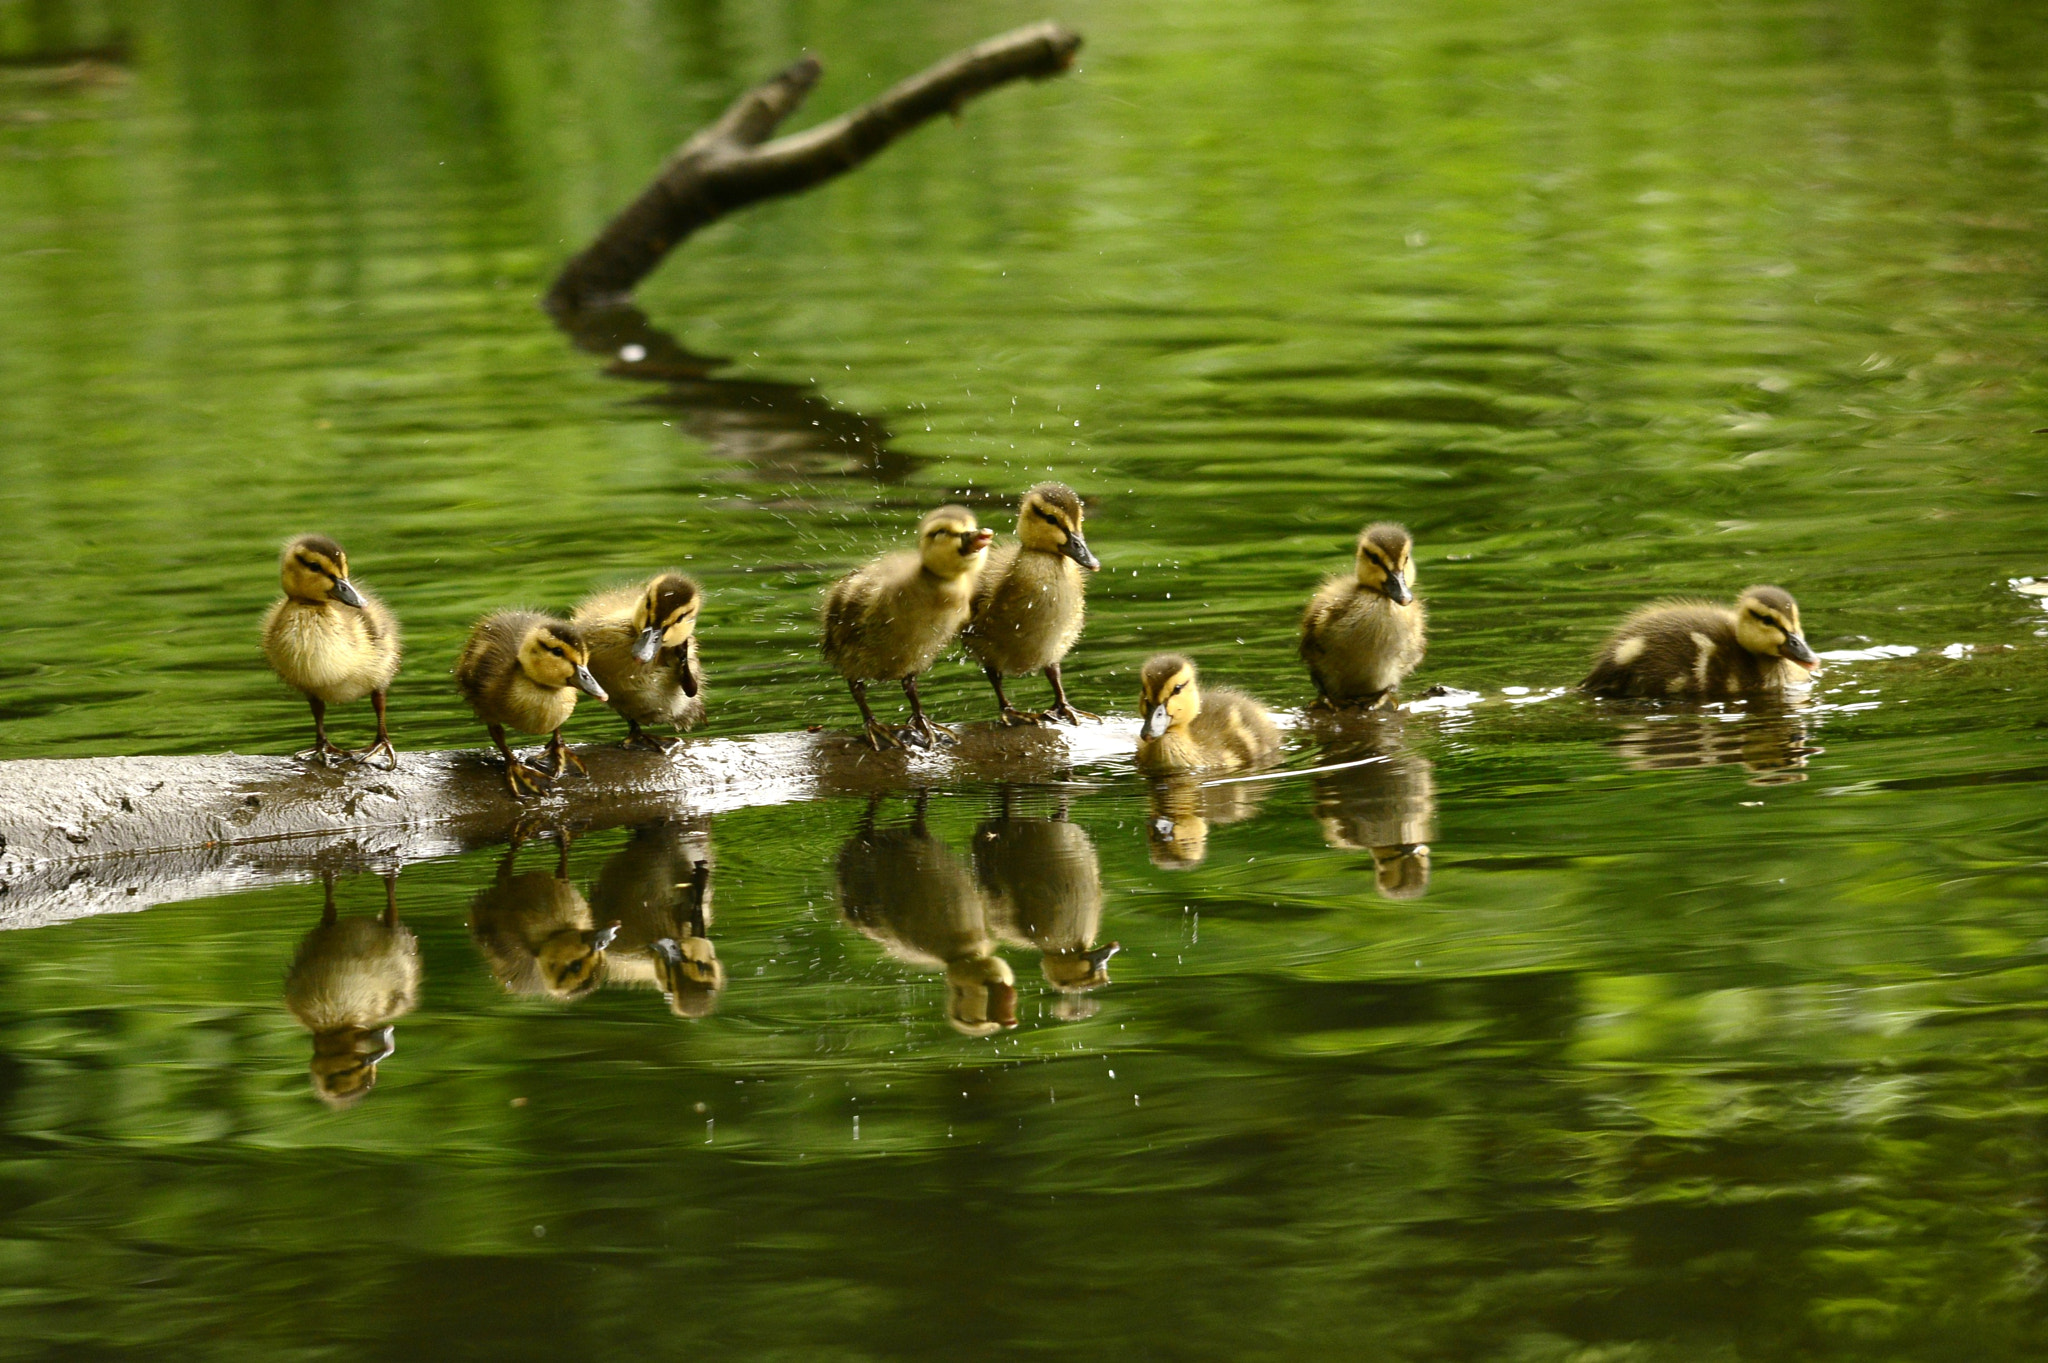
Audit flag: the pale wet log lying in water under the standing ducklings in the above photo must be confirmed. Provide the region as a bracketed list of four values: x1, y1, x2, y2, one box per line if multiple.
[0, 722, 1135, 929]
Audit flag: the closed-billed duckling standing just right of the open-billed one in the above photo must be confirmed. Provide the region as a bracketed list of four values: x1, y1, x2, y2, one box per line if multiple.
[961, 483, 1102, 724]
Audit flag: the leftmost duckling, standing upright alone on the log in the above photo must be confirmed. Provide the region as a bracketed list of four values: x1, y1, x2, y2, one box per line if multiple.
[262, 534, 399, 770]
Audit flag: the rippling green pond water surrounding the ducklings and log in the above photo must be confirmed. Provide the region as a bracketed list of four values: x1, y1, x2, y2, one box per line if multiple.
[0, 0, 2048, 1363]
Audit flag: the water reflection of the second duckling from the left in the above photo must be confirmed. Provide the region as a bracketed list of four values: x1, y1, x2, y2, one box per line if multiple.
[469, 835, 618, 1001]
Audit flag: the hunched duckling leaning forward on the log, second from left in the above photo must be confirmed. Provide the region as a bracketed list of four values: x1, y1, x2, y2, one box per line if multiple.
[455, 610, 608, 798]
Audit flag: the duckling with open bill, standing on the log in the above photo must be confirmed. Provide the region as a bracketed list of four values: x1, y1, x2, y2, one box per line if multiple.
[821, 505, 991, 751]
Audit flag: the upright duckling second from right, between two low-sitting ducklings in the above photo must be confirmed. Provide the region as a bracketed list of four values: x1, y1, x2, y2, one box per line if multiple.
[1300, 520, 1427, 710]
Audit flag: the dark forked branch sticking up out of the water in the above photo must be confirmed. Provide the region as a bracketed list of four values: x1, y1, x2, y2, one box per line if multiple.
[547, 23, 1081, 315]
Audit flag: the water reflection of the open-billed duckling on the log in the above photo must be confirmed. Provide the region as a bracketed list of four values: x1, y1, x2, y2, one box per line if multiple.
[840, 790, 1018, 1036]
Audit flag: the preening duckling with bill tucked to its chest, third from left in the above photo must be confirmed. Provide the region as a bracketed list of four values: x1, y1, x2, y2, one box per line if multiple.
[569, 569, 705, 753]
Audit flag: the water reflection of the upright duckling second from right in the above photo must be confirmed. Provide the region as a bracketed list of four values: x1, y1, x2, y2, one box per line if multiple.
[1309, 716, 1436, 898]
